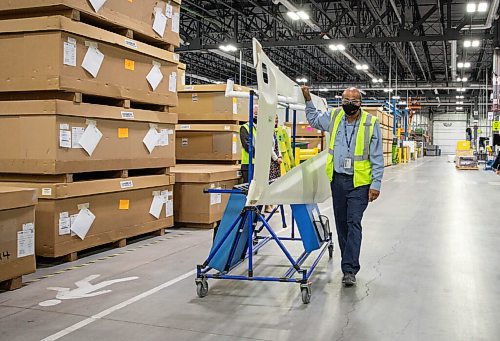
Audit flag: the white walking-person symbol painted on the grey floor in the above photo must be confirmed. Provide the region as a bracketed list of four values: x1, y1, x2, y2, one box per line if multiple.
[38, 275, 139, 307]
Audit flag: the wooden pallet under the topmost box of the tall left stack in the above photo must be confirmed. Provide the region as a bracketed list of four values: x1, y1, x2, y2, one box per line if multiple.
[1, 5, 175, 52]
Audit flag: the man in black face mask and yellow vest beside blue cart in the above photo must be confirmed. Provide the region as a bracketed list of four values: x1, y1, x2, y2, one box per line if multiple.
[302, 86, 384, 287]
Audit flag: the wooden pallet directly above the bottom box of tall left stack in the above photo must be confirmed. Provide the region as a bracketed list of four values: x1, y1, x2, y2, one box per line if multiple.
[0, 167, 170, 183]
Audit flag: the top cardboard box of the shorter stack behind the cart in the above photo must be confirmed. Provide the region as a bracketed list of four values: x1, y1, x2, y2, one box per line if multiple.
[176, 85, 250, 122]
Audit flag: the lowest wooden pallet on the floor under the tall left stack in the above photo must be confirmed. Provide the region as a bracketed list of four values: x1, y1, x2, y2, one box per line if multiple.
[37, 227, 169, 267]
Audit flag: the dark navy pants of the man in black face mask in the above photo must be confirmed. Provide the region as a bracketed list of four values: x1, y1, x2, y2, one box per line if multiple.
[331, 173, 370, 274]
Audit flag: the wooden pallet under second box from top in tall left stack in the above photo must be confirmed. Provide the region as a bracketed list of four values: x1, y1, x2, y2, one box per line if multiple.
[0, 91, 168, 113]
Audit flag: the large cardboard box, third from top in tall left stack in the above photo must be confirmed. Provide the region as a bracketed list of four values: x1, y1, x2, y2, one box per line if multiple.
[0, 100, 177, 174]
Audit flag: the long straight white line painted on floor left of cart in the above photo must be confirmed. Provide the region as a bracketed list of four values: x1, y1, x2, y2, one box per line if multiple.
[41, 270, 196, 341]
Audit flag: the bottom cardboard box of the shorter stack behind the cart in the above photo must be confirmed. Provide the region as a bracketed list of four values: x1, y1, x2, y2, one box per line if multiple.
[172, 165, 241, 224]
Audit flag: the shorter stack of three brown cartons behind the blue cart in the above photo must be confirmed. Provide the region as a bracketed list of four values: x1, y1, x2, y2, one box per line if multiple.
[172, 84, 249, 228]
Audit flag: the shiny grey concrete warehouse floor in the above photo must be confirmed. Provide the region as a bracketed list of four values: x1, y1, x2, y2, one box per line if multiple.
[0, 157, 500, 341]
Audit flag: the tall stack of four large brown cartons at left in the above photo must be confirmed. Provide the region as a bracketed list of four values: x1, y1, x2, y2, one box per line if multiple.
[0, 0, 180, 259]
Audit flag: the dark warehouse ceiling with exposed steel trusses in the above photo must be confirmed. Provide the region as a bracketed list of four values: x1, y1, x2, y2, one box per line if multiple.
[179, 0, 499, 98]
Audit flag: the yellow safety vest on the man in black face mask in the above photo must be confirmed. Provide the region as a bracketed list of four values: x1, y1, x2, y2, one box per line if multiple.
[326, 109, 377, 187]
